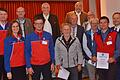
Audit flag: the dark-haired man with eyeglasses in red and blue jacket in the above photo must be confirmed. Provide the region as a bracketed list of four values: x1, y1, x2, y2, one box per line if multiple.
[25, 16, 54, 80]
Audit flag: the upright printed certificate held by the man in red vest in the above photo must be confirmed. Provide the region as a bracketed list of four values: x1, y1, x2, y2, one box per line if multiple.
[96, 52, 109, 69]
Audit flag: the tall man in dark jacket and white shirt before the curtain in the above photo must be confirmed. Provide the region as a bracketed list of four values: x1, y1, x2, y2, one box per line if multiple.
[36, 3, 60, 43]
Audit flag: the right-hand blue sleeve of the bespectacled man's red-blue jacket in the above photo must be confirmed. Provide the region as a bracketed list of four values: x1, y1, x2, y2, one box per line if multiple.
[49, 35, 55, 63]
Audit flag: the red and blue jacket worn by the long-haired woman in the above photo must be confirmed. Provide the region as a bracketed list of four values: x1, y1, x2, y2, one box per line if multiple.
[4, 36, 25, 72]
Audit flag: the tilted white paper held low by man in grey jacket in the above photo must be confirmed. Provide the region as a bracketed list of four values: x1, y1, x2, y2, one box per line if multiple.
[58, 67, 70, 80]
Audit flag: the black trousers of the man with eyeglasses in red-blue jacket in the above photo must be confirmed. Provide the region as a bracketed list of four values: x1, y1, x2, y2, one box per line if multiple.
[32, 62, 52, 80]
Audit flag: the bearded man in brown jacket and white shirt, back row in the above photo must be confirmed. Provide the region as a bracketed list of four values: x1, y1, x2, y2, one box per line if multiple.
[65, 2, 88, 25]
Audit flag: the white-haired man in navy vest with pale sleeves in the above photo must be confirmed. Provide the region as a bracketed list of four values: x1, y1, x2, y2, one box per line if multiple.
[83, 18, 99, 80]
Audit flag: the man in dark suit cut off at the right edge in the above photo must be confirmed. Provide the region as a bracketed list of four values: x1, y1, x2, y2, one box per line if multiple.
[112, 12, 120, 80]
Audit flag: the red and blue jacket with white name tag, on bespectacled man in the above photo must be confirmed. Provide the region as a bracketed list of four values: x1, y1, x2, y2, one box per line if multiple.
[25, 31, 54, 68]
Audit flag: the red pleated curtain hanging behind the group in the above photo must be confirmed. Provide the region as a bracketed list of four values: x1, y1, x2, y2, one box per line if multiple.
[0, 0, 89, 24]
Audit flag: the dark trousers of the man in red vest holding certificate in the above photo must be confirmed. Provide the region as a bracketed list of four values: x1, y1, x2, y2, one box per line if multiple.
[97, 63, 117, 80]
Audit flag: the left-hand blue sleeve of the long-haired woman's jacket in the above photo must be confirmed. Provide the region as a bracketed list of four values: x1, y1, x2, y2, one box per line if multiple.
[4, 39, 12, 73]
